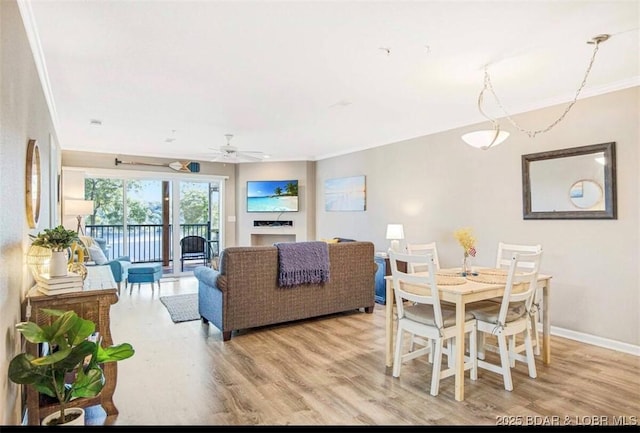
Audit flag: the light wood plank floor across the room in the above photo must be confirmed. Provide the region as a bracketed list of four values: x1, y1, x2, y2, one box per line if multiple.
[87, 277, 640, 425]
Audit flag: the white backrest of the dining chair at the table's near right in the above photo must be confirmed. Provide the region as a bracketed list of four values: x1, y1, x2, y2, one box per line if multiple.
[498, 250, 542, 325]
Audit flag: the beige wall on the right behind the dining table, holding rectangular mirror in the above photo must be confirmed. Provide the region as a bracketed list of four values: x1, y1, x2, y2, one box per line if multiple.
[316, 87, 640, 346]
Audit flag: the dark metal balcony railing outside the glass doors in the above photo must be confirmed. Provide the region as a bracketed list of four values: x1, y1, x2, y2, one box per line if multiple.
[86, 224, 219, 263]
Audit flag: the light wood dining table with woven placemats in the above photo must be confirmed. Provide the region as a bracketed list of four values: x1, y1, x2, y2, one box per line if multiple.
[385, 268, 551, 401]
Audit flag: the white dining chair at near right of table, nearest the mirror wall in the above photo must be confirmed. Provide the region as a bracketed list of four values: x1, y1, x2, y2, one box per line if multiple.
[467, 246, 542, 391]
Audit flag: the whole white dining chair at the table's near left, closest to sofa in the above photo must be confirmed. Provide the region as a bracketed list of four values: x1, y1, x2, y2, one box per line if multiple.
[389, 251, 478, 396]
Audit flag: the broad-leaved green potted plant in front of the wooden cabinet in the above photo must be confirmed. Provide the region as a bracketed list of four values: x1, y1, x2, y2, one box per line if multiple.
[9, 309, 134, 425]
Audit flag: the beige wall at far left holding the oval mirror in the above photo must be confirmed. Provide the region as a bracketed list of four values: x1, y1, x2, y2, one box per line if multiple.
[0, 0, 58, 425]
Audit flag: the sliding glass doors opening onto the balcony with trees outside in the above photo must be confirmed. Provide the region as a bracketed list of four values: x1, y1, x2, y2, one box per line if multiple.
[85, 177, 221, 274]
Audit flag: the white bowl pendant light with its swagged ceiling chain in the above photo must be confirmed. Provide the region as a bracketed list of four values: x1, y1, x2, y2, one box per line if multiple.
[462, 34, 609, 150]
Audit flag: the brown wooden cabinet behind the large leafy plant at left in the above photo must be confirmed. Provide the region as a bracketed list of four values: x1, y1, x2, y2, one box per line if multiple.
[22, 288, 118, 425]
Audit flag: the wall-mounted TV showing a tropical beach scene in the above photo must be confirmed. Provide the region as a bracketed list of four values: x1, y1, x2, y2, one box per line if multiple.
[247, 180, 298, 212]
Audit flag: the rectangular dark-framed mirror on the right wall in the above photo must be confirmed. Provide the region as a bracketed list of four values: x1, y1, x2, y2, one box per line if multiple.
[522, 142, 617, 219]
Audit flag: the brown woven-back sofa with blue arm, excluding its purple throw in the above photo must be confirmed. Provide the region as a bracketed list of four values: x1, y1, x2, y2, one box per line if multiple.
[194, 242, 377, 341]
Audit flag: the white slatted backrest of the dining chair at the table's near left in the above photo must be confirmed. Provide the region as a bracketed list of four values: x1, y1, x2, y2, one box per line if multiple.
[389, 250, 443, 328]
